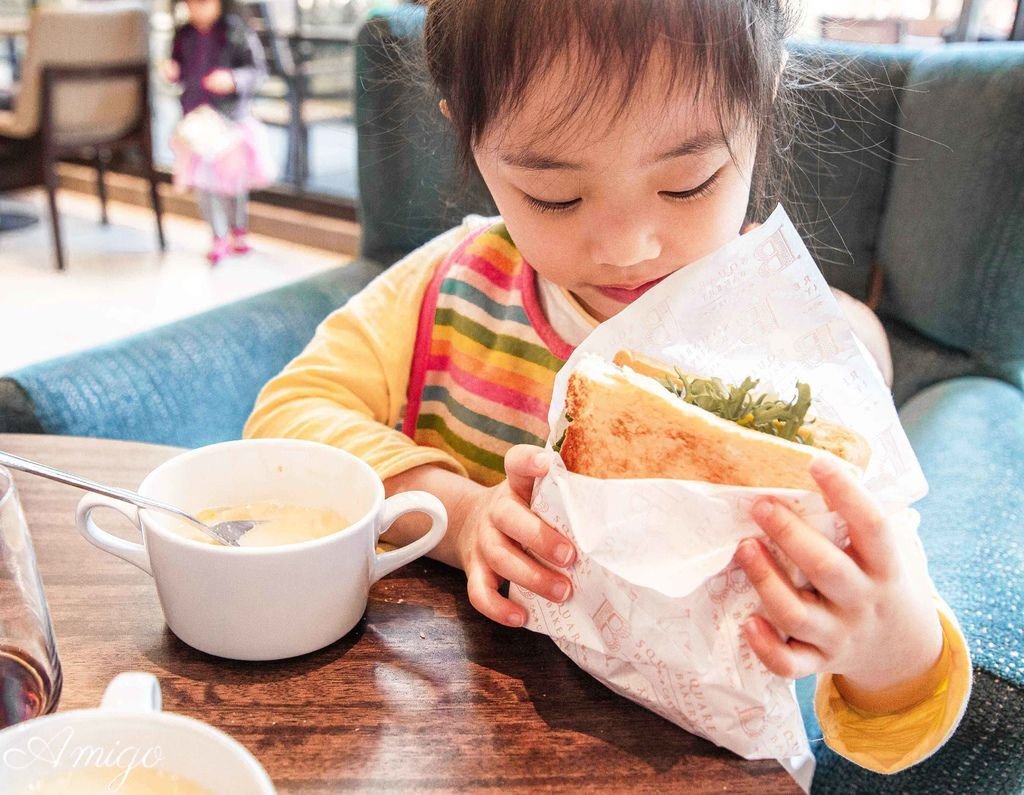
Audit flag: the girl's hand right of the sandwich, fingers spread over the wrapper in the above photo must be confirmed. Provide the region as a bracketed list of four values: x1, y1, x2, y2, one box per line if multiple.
[735, 458, 942, 709]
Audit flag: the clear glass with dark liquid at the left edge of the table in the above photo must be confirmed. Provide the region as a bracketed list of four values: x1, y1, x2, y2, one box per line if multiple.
[0, 467, 61, 728]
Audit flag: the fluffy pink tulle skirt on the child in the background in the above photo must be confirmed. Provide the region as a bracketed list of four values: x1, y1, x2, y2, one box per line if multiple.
[171, 106, 276, 196]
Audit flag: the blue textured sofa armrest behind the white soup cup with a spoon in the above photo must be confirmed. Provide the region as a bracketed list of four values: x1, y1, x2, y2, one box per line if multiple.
[0, 260, 380, 447]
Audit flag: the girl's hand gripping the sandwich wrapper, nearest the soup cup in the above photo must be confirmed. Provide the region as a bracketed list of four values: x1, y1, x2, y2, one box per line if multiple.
[456, 445, 575, 627]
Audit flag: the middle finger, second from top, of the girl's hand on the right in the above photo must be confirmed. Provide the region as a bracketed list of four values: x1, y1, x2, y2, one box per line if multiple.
[753, 498, 864, 604]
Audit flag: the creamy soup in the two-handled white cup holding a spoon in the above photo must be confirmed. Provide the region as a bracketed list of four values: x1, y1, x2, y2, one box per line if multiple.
[174, 502, 351, 546]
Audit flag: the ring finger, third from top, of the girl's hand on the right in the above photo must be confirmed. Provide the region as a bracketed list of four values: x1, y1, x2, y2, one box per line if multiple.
[736, 538, 837, 647]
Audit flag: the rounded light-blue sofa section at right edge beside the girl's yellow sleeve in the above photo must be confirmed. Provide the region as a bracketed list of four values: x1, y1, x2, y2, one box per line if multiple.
[900, 378, 1024, 687]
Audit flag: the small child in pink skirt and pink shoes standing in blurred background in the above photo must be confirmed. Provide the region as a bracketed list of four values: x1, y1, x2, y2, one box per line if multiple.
[164, 0, 272, 264]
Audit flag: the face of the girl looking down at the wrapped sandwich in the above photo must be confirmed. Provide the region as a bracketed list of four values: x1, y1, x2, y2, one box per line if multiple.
[473, 50, 756, 320]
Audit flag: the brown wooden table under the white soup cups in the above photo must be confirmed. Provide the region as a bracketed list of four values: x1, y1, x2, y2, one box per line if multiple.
[0, 434, 798, 795]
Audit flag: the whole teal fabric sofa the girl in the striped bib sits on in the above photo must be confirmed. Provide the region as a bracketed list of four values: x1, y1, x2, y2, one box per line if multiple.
[0, 6, 1024, 794]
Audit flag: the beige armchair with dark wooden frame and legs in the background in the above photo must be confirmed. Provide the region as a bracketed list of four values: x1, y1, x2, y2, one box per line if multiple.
[0, 3, 165, 269]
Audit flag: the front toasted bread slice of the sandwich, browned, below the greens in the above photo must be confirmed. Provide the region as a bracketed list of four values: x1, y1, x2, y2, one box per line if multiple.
[561, 357, 869, 491]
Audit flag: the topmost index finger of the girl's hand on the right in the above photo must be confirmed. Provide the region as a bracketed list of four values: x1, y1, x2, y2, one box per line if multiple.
[811, 457, 899, 577]
